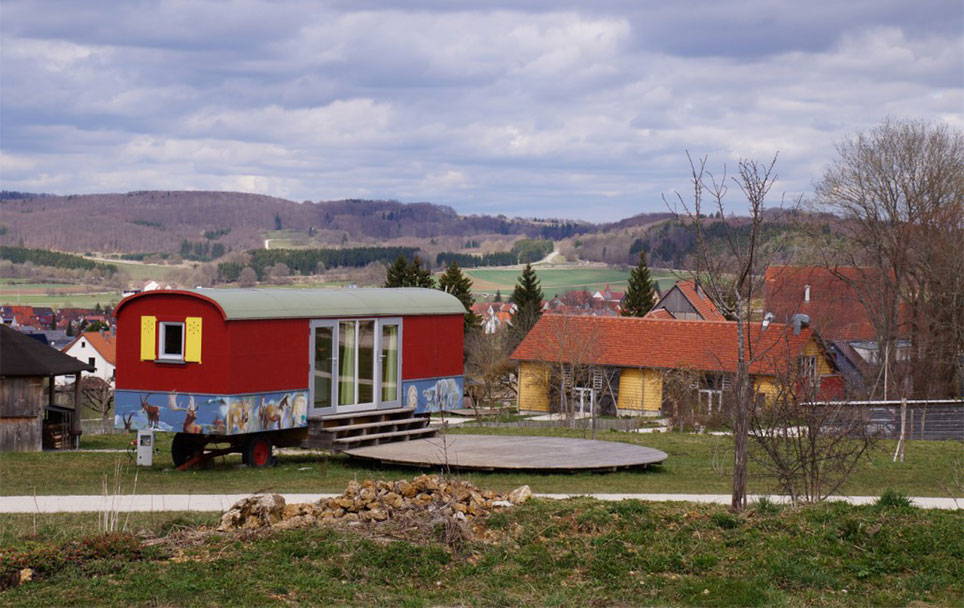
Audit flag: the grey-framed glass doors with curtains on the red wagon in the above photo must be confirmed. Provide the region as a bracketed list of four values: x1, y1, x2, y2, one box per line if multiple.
[310, 318, 402, 415]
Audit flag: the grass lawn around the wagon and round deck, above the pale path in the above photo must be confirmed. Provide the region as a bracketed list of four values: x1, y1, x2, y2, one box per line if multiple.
[0, 428, 964, 496]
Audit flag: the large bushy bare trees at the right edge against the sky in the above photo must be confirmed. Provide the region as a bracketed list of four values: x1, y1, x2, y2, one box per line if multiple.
[815, 119, 964, 397]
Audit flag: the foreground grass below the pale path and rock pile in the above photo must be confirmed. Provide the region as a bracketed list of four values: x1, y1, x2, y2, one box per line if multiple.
[0, 499, 964, 607]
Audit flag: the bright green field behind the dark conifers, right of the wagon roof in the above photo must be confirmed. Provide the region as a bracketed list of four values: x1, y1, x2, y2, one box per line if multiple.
[465, 267, 676, 298]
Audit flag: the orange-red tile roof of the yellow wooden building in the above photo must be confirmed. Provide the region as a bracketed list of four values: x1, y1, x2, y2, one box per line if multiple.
[512, 315, 814, 375]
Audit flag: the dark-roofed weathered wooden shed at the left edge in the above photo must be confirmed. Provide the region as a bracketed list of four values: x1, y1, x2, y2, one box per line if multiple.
[0, 325, 93, 452]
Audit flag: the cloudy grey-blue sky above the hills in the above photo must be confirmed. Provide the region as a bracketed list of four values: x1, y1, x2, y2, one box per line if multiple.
[0, 0, 964, 220]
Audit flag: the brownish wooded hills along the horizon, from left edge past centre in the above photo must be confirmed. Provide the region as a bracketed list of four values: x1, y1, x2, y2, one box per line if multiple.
[0, 191, 595, 258]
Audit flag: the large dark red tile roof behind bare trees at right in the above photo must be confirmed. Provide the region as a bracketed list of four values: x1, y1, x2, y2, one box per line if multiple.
[764, 266, 906, 341]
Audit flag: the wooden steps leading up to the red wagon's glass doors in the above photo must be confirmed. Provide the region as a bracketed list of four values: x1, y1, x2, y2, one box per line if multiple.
[302, 407, 438, 452]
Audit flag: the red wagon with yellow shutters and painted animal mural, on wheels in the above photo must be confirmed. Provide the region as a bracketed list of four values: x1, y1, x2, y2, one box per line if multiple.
[114, 288, 465, 466]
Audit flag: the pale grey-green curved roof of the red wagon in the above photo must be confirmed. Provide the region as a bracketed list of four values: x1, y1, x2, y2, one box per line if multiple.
[185, 287, 465, 320]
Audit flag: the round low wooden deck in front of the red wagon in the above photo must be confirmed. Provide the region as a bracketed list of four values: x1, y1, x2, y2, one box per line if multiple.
[344, 435, 666, 471]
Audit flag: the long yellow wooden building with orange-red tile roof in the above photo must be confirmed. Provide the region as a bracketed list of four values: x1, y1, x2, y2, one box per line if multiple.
[512, 314, 840, 415]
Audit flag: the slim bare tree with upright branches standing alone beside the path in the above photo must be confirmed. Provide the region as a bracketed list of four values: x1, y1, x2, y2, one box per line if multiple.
[667, 153, 777, 511]
